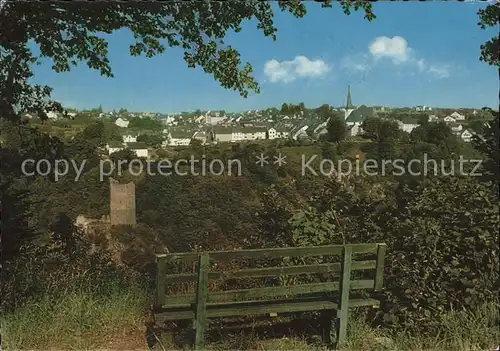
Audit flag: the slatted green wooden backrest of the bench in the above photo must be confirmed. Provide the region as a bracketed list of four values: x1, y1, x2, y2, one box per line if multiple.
[155, 243, 386, 308]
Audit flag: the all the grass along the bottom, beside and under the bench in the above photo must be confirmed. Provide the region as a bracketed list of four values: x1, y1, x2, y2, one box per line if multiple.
[0, 286, 500, 351]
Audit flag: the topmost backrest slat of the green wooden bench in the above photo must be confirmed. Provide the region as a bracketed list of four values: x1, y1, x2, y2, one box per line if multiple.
[156, 243, 378, 262]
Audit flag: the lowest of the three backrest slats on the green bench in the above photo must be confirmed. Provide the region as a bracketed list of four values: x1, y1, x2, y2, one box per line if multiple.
[163, 279, 374, 307]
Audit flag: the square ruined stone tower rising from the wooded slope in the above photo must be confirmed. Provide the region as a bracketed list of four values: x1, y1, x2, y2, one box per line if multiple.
[109, 178, 136, 226]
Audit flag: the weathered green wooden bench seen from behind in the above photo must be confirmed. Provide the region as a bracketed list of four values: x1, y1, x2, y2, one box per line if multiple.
[153, 244, 386, 350]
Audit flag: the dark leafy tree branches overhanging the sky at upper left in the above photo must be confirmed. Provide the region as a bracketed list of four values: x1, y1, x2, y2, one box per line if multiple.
[0, 0, 375, 119]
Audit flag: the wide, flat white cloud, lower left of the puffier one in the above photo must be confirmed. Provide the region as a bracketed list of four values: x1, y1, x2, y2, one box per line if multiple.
[264, 56, 330, 83]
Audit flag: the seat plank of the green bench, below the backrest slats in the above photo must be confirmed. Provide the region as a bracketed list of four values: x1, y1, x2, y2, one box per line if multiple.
[155, 298, 379, 321]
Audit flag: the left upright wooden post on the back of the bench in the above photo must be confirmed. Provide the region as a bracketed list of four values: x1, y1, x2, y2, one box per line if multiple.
[195, 253, 210, 350]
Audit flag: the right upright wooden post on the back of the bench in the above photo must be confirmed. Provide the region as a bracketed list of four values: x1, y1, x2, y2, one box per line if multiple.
[337, 245, 352, 347]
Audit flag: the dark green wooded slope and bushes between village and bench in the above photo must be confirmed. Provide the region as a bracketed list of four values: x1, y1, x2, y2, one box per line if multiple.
[2, 114, 499, 342]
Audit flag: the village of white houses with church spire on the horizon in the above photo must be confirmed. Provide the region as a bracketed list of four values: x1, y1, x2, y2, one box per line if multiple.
[25, 87, 491, 158]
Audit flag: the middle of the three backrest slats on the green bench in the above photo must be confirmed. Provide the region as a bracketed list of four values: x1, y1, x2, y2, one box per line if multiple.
[167, 260, 377, 283]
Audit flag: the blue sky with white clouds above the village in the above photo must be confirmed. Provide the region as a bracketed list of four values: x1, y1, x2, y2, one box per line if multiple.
[33, 2, 499, 113]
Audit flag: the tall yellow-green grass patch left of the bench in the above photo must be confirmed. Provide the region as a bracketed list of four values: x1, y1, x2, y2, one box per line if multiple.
[0, 286, 147, 350]
